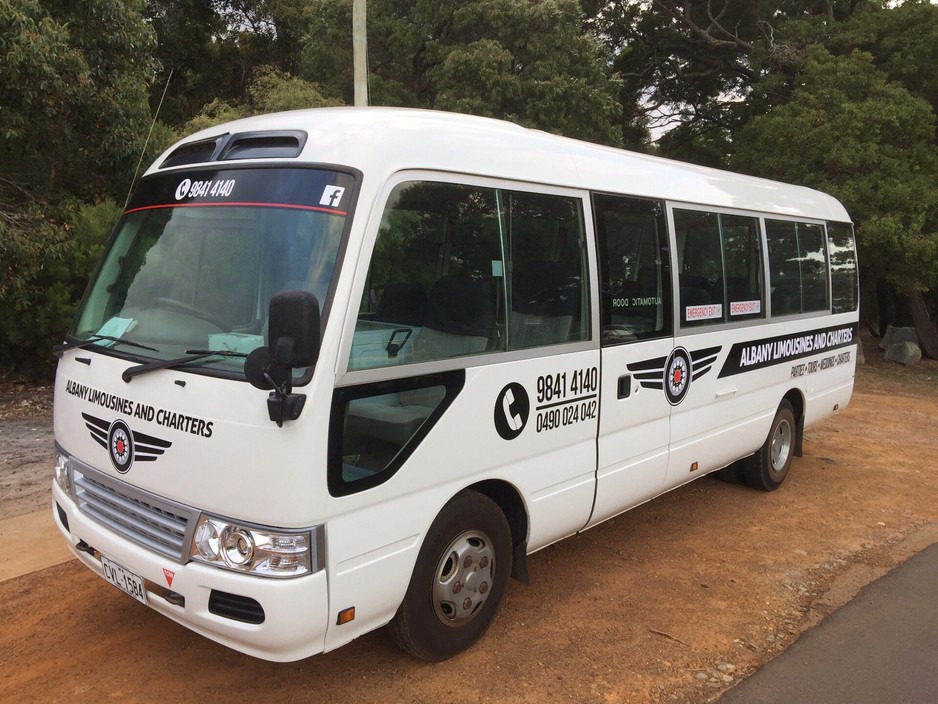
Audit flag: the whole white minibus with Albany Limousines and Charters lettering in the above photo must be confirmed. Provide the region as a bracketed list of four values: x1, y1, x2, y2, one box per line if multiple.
[53, 108, 858, 661]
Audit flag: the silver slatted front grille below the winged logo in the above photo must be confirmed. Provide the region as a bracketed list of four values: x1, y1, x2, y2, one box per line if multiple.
[72, 459, 198, 562]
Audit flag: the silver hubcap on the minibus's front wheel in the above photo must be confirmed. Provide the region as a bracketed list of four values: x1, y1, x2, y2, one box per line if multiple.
[433, 531, 495, 626]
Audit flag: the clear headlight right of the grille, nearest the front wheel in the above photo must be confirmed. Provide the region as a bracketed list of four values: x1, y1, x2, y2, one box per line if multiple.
[189, 514, 322, 577]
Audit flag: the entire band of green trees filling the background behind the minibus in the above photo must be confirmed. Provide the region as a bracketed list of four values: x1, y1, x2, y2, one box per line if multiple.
[11, 0, 938, 368]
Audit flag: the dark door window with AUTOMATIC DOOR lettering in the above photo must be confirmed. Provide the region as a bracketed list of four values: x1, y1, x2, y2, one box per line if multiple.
[593, 194, 672, 345]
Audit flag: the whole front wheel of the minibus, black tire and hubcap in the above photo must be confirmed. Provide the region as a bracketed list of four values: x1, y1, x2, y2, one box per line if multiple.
[391, 491, 512, 662]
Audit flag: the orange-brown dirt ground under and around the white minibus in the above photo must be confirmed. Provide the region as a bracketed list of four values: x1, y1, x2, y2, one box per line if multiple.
[0, 332, 938, 704]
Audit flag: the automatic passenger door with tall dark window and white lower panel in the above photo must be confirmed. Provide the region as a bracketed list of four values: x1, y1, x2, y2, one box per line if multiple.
[589, 195, 674, 525]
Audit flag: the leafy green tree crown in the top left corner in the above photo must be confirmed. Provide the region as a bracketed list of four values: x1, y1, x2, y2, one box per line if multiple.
[0, 0, 153, 201]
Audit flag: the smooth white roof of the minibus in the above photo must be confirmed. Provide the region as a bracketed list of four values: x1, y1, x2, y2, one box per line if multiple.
[147, 107, 850, 222]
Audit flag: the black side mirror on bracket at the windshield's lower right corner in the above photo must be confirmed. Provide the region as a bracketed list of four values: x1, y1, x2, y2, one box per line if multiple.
[244, 291, 320, 426]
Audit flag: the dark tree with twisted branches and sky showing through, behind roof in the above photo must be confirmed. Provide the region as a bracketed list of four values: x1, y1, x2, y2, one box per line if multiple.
[587, 0, 881, 161]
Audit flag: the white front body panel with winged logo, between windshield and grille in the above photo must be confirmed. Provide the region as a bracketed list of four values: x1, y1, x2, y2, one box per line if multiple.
[55, 351, 331, 528]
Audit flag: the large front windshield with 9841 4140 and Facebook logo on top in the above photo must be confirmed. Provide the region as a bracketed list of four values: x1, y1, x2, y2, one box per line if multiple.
[71, 169, 354, 372]
